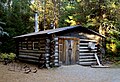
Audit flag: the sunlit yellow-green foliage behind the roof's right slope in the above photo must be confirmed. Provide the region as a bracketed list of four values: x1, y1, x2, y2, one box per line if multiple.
[60, 0, 120, 58]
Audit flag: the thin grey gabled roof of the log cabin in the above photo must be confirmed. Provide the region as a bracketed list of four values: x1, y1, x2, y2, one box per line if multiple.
[13, 25, 105, 39]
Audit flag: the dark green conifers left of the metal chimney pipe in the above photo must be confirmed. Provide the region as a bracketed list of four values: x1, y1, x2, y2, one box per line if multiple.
[0, 0, 34, 53]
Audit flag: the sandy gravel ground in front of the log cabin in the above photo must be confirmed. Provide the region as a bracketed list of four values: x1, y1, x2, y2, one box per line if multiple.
[0, 63, 120, 82]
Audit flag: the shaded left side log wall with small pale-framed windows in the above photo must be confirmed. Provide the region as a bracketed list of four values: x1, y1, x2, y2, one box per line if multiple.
[18, 37, 46, 62]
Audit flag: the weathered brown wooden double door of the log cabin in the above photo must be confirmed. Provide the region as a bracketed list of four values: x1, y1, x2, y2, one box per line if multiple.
[59, 37, 79, 65]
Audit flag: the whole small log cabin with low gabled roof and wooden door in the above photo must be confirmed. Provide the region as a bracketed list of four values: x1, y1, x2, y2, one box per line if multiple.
[14, 25, 105, 67]
